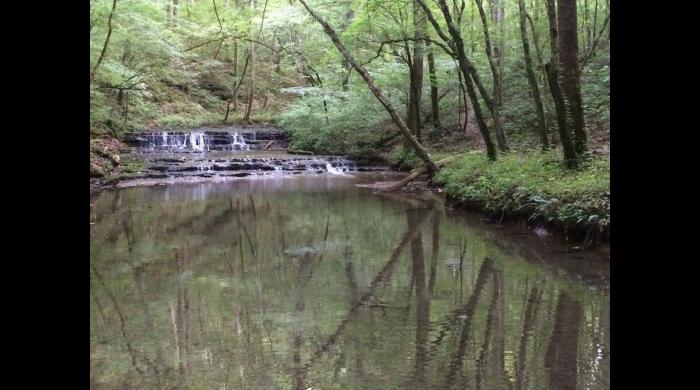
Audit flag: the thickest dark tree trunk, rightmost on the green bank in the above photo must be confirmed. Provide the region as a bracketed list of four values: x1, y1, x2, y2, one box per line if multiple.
[557, 0, 588, 155]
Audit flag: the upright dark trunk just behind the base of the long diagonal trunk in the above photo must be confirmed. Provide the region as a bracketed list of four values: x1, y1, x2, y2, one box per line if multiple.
[406, 0, 426, 141]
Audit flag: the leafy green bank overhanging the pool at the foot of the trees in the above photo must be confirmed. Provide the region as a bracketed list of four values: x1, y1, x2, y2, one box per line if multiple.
[435, 152, 610, 243]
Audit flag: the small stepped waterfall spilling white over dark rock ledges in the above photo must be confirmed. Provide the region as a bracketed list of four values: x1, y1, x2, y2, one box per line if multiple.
[116, 128, 384, 184]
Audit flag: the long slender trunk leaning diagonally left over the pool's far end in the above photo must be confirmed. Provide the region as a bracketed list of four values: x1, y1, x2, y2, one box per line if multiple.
[299, 0, 437, 174]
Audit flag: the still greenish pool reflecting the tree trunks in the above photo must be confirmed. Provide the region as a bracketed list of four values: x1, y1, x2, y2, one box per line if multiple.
[90, 175, 610, 389]
